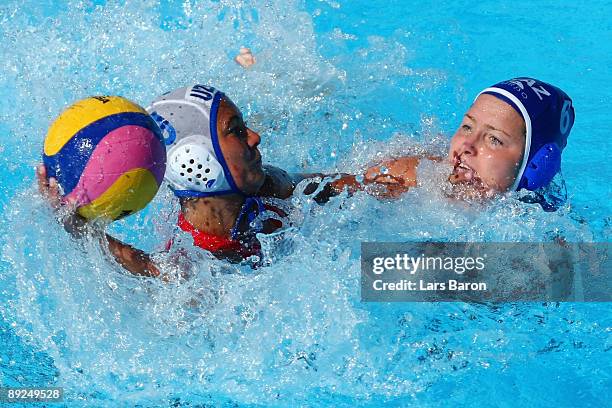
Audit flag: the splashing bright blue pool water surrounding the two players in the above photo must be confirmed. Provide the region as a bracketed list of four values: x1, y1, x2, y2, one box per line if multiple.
[0, 0, 612, 407]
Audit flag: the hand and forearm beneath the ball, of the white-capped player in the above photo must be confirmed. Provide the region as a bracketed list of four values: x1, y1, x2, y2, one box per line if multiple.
[36, 164, 160, 277]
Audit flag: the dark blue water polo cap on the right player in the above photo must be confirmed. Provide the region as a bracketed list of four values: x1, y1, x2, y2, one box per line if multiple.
[478, 77, 574, 191]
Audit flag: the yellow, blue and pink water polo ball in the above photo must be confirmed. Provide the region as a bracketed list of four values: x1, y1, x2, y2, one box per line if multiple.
[43, 96, 166, 220]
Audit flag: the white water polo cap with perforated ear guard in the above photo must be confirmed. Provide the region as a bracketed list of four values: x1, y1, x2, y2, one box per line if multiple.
[147, 85, 243, 197]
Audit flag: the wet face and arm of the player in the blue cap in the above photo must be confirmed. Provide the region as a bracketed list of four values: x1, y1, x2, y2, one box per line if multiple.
[365, 94, 525, 198]
